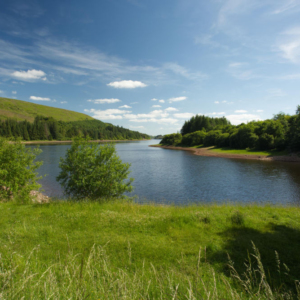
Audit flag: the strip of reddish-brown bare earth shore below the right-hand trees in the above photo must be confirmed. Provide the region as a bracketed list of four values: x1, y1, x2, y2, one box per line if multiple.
[150, 145, 300, 163]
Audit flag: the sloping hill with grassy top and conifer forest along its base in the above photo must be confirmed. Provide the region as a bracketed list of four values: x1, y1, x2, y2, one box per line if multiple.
[0, 97, 150, 141]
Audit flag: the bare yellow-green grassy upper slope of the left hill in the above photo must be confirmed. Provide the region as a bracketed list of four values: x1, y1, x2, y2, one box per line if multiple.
[0, 97, 94, 122]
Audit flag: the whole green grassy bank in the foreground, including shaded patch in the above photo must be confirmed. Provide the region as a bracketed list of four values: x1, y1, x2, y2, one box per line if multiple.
[0, 202, 300, 299]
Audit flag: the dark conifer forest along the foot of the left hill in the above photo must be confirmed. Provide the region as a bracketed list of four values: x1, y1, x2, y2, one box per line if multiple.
[0, 116, 150, 141]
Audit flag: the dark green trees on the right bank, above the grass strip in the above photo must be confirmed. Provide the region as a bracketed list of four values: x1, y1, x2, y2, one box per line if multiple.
[160, 106, 300, 151]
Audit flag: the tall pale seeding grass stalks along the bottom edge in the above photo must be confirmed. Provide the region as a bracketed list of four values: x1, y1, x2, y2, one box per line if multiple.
[0, 244, 300, 300]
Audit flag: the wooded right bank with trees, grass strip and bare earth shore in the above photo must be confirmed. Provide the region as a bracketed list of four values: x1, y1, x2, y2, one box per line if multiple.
[156, 106, 300, 162]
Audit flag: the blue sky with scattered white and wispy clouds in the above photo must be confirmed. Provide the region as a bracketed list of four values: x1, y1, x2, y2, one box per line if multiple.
[0, 0, 300, 135]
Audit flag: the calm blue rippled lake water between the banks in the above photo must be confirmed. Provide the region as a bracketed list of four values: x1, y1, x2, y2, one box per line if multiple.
[29, 140, 300, 205]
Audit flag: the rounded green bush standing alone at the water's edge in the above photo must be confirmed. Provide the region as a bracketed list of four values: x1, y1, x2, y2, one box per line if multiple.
[56, 138, 133, 200]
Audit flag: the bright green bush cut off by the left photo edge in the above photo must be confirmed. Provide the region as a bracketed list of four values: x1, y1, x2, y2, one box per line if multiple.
[0, 138, 43, 203]
